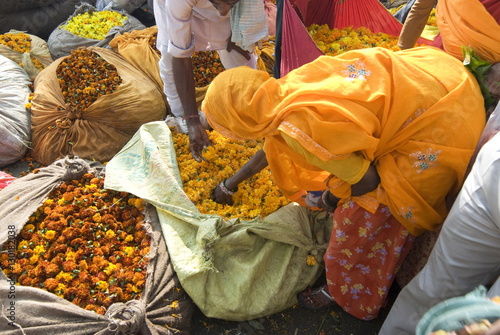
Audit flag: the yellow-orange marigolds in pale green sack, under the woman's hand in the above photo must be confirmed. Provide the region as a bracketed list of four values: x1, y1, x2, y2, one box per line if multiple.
[173, 130, 290, 220]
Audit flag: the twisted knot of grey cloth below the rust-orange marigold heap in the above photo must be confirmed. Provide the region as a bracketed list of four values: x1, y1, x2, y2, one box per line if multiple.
[106, 300, 146, 334]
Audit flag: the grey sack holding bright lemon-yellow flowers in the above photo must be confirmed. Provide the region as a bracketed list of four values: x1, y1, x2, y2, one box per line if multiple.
[47, 3, 146, 59]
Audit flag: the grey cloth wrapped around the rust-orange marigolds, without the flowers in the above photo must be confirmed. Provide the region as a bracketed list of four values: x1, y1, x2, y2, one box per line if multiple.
[0, 159, 194, 335]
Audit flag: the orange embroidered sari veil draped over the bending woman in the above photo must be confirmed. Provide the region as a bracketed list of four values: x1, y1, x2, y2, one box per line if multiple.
[202, 47, 485, 234]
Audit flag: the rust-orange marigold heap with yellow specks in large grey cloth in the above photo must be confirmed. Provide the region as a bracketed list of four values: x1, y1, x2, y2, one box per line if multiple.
[0, 173, 150, 314]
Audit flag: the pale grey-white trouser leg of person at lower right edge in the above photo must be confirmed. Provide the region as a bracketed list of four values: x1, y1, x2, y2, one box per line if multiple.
[379, 194, 500, 335]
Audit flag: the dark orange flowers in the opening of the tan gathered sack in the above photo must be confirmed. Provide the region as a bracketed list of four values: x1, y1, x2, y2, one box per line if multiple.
[56, 49, 122, 111]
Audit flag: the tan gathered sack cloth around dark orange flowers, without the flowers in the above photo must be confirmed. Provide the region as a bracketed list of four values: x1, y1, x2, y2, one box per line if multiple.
[32, 47, 166, 165]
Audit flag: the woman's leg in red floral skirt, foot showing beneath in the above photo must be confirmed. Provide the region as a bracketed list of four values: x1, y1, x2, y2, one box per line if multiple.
[301, 201, 414, 320]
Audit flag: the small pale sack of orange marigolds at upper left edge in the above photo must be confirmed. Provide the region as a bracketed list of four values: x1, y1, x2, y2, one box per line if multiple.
[0, 29, 53, 80]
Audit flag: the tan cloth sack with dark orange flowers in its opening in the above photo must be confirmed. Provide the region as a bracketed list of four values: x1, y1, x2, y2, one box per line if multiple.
[32, 47, 166, 165]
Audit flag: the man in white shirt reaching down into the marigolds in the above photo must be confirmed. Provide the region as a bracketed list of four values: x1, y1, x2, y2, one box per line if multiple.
[154, 0, 264, 161]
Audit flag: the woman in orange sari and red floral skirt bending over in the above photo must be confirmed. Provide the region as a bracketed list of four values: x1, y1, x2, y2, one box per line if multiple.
[202, 48, 485, 320]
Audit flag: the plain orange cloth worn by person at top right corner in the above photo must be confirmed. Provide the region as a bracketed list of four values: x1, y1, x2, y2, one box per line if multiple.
[436, 0, 500, 63]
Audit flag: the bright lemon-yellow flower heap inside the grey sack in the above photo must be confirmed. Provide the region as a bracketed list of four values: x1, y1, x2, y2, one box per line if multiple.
[61, 10, 127, 41]
